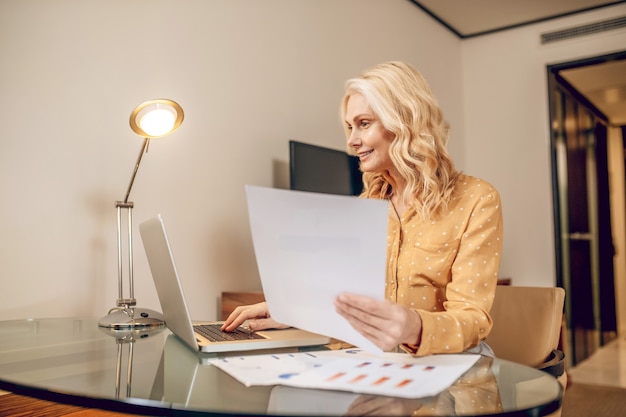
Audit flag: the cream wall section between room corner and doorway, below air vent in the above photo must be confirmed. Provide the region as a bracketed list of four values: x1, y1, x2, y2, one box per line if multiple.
[462, 4, 626, 286]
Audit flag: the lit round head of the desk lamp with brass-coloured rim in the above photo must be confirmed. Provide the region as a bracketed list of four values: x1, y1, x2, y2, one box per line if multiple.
[130, 99, 185, 139]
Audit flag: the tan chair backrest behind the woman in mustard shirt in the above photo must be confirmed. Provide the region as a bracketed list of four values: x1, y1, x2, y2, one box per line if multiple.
[487, 285, 565, 367]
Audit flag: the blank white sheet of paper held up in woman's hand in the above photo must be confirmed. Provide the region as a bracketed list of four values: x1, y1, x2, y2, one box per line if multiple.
[246, 187, 389, 353]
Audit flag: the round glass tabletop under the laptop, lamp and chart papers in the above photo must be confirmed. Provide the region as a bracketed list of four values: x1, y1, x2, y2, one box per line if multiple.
[0, 318, 563, 416]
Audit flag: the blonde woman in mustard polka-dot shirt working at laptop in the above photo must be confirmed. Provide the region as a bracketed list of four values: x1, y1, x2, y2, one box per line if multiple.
[223, 62, 503, 356]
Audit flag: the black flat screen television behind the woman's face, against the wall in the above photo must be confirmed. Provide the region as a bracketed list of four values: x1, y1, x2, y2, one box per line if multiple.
[289, 140, 363, 195]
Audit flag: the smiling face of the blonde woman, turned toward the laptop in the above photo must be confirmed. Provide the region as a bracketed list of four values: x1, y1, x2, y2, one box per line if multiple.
[345, 94, 394, 172]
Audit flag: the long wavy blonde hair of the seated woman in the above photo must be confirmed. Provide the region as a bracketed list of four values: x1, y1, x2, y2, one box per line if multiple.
[341, 62, 460, 219]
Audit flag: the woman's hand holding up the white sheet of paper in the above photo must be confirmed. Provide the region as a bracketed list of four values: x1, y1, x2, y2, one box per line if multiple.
[335, 293, 422, 351]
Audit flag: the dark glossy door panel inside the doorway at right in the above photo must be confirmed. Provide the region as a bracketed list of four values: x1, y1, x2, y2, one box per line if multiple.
[549, 71, 617, 365]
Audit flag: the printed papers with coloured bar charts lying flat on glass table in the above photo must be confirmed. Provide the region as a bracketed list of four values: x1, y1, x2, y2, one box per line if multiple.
[210, 349, 480, 398]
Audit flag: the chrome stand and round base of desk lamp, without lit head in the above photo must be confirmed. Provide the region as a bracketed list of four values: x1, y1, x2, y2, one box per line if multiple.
[98, 138, 165, 330]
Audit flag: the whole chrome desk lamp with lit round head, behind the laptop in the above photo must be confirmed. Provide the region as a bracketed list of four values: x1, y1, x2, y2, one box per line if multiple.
[98, 99, 184, 330]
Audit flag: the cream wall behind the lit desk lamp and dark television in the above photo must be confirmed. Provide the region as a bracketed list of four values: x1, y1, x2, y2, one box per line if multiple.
[0, 0, 458, 320]
